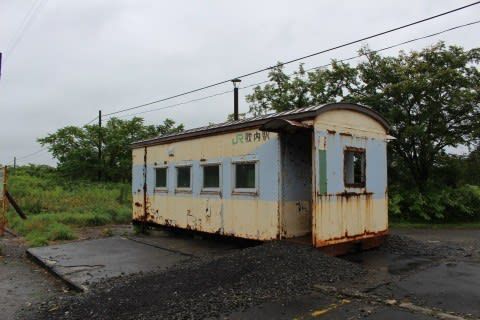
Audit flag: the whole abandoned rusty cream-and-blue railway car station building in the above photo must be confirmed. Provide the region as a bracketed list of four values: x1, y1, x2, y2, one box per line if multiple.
[132, 103, 390, 248]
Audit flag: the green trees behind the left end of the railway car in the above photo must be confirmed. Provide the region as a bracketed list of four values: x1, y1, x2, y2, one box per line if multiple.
[38, 117, 183, 181]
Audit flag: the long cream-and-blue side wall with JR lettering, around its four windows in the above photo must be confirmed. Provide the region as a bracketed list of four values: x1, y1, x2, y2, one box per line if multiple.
[132, 130, 280, 240]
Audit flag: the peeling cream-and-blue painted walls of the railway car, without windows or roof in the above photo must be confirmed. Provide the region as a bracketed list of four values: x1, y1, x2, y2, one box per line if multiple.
[132, 106, 388, 246]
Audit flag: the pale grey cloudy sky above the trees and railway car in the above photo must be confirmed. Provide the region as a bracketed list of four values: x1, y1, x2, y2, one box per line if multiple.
[0, 0, 480, 164]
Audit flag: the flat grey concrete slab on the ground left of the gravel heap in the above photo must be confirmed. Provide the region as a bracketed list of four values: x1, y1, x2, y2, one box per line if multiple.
[27, 237, 191, 290]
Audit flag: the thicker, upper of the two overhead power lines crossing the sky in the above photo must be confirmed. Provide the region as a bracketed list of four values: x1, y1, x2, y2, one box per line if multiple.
[104, 1, 480, 116]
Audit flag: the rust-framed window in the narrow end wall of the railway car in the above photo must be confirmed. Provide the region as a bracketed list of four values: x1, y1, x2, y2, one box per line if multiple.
[343, 147, 365, 188]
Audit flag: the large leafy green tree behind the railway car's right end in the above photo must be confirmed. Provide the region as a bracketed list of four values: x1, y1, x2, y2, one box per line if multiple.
[247, 42, 480, 220]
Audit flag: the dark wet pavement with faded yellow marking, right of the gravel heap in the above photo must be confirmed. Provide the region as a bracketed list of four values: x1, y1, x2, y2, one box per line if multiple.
[228, 229, 480, 320]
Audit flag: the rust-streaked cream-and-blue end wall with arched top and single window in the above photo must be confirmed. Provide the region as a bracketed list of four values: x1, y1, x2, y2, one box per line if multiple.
[313, 110, 388, 246]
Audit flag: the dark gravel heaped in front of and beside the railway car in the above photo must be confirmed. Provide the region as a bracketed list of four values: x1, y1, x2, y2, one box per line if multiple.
[21, 235, 472, 320]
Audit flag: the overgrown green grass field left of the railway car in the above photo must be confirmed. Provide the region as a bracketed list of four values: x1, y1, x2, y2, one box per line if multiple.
[7, 167, 131, 246]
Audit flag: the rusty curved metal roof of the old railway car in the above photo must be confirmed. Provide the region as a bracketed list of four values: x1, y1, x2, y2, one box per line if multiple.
[132, 103, 389, 148]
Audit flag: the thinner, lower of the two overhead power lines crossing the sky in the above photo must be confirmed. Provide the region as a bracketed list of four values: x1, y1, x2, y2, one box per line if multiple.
[107, 20, 480, 122]
